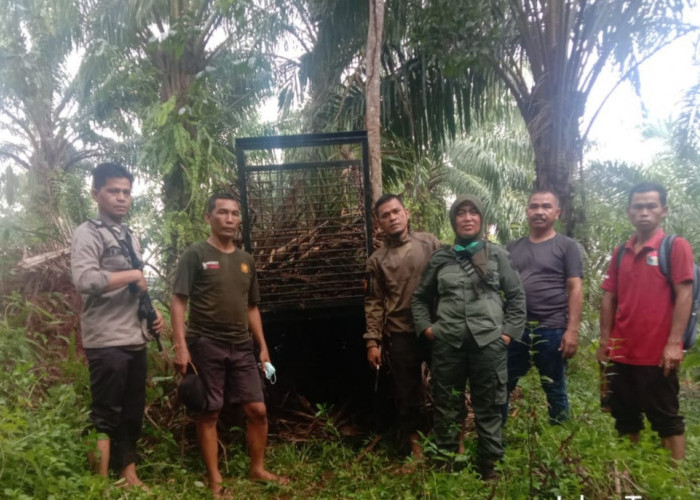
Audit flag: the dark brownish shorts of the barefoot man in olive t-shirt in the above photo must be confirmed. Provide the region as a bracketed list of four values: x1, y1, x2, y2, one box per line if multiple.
[187, 337, 264, 411]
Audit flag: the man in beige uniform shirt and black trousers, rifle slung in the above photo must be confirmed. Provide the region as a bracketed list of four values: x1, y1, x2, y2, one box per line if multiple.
[71, 163, 163, 486]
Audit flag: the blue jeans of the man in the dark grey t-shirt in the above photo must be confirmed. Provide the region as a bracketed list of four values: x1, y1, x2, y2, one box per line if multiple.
[503, 328, 569, 425]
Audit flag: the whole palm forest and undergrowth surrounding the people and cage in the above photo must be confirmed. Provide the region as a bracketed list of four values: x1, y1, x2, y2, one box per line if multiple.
[0, 0, 700, 498]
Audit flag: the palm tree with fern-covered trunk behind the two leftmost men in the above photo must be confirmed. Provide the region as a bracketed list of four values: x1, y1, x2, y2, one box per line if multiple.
[82, 0, 279, 270]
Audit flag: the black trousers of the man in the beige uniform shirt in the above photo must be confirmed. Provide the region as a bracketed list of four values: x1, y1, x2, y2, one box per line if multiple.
[85, 347, 146, 470]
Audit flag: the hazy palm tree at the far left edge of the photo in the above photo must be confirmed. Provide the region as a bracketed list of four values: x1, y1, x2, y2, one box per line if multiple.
[0, 0, 98, 242]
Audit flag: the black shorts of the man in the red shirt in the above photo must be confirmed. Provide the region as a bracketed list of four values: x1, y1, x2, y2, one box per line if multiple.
[607, 363, 685, 438]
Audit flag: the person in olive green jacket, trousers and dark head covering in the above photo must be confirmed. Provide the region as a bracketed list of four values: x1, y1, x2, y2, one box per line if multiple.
[412, 196, 527, 479]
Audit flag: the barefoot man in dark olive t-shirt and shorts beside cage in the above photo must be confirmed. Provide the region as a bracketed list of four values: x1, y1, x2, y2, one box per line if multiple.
[171, 194, 289, 498]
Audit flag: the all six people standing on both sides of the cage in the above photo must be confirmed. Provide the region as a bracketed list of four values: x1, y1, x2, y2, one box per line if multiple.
[71, 163, 693, 498]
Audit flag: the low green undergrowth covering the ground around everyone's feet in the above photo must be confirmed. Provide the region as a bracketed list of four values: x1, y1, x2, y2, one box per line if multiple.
[0, 297, 700, 500]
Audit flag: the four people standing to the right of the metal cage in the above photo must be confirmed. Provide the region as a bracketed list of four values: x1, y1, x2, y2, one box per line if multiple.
[364, 183, 693, 480]
